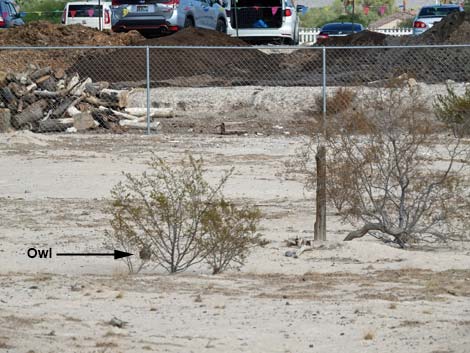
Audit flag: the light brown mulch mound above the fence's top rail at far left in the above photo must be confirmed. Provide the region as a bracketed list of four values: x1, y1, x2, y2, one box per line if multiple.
[0, 21, 143, 46]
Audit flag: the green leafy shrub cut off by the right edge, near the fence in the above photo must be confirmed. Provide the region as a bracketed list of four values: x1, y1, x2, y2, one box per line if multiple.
[434, 85, 470, 136]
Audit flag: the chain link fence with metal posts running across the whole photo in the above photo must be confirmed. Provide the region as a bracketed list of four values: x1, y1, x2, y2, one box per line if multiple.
[0, 45, 470, 134]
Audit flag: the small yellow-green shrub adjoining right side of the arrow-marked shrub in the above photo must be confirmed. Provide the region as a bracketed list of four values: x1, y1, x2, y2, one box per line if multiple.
[202, 199, 261, 274]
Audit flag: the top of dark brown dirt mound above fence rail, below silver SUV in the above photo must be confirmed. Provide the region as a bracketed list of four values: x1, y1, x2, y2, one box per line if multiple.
[139, 27, 248, 47]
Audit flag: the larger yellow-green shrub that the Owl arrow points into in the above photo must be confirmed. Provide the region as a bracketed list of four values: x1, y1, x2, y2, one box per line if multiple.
[106, 155, 264, 273]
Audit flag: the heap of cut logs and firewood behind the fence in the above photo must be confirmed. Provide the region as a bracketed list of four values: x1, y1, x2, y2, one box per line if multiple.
[0, 65, 168, 133]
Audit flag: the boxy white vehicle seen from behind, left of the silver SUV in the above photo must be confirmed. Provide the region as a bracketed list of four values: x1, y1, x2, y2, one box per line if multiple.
[62, 0, 111, 30]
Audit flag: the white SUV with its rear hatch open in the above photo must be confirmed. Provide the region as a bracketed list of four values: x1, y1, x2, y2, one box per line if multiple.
[225, 0, 299, 44]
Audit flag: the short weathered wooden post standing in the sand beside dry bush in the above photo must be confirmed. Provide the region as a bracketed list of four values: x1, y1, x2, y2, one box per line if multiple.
[314, 145, 326, 240]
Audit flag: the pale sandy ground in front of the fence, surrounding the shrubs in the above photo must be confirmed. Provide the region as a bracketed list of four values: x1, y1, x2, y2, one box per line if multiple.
[0, 133, 470, 353]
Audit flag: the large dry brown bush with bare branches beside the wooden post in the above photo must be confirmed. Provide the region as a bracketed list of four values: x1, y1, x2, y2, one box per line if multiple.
[300, 87, 470, 247]
